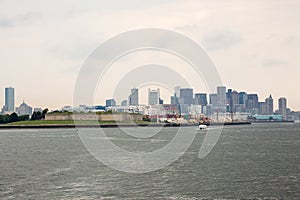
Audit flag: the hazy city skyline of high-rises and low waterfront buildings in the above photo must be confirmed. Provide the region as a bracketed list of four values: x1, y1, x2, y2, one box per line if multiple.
[1, 86, 300, 122]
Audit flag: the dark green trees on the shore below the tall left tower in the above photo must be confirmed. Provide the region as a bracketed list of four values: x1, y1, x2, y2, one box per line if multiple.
[0, 108, 48, 124]
